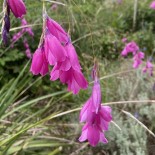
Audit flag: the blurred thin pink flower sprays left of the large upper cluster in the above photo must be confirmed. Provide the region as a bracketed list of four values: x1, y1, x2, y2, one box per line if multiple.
[12, 18, 34, 58]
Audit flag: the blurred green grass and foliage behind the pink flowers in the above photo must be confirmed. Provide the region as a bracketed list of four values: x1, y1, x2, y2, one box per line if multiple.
[0, 0, 155, 155]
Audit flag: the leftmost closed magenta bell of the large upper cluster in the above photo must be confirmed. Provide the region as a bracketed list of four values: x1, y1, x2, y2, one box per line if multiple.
[30, 47, 48, 76]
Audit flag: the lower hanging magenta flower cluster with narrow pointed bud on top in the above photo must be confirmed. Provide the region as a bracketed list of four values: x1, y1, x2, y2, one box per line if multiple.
[79, 65, 112, 146]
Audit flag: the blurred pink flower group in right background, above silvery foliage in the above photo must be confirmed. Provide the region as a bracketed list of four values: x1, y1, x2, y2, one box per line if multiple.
[121, 38, 153, 75]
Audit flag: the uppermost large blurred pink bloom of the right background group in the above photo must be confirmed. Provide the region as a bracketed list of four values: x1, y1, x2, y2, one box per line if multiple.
[121, 41, 139, 56]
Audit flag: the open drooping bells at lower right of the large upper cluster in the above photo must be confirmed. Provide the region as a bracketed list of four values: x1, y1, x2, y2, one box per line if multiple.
[50, 44, 88, 94]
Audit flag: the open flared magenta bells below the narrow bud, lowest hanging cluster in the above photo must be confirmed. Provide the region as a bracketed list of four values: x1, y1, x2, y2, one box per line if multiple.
[79, 105, 112, 146]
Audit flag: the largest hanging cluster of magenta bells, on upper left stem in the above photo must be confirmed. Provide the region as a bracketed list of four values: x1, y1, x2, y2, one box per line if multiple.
[30, 14, 88, 94]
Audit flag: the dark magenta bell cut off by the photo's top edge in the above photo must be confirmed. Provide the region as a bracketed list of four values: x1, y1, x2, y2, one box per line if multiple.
[7, 0, 26, 18]
